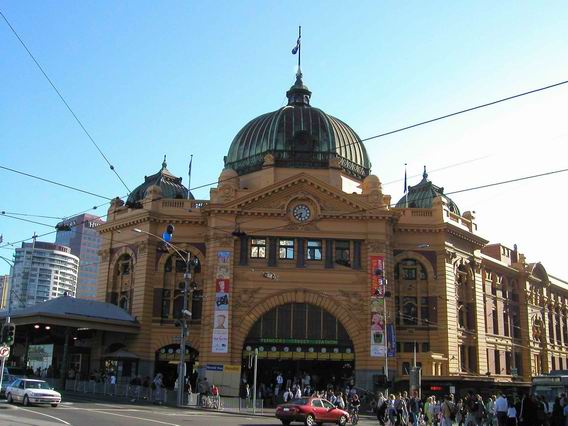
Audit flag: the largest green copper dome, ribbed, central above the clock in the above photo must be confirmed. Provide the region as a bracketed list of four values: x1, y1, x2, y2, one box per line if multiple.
[225, 73, 371, 179]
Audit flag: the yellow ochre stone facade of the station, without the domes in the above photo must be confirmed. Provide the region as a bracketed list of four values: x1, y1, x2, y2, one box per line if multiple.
[94, 74, 568, 394]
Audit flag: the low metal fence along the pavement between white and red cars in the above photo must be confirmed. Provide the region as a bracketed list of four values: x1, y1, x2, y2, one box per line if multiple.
[65, 380, 264, 414]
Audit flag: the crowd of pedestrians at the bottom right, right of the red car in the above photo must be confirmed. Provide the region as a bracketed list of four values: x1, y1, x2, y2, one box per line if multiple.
[376, 391, 568, 426]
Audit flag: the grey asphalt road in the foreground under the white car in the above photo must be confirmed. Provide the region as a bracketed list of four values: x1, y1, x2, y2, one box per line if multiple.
[0, 398, 378, 426]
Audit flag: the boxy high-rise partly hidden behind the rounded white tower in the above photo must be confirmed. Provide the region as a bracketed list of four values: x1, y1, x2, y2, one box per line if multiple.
[55, 214, 104, 299]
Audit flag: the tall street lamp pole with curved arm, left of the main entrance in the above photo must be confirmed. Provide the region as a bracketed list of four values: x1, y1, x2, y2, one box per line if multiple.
[133, 225, 199, 406]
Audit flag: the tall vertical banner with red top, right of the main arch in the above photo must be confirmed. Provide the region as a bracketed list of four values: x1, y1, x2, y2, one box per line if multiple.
[369, 256, 387, 357]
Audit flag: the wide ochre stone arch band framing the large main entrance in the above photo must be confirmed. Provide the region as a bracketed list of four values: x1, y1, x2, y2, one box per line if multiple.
[231, 289, 362, 358]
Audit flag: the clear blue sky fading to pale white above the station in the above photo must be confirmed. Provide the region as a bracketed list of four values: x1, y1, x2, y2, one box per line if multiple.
[0, 0, 568, 280]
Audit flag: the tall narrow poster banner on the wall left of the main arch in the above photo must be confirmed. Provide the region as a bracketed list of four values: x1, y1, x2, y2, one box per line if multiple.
[211, 250, 231, 353]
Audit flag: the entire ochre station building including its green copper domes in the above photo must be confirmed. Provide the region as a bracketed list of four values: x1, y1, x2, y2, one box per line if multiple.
[6, 70, 568, 395]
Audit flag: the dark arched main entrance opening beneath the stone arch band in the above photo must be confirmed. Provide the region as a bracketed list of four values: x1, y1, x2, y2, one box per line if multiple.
[242, 303, 355, 399]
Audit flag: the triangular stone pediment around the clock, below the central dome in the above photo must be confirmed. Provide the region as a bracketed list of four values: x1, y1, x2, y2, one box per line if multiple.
[223, 173, 376, 215]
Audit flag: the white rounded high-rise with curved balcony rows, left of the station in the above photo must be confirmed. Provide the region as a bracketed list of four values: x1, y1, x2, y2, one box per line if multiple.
[10, 241, 79, 309]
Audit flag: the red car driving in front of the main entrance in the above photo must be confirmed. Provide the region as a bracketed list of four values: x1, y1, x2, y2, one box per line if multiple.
[276, 397, 349, 426]
